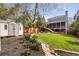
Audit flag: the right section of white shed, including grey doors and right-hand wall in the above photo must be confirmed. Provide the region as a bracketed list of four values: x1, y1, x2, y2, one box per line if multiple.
[8, 22, 23, 36]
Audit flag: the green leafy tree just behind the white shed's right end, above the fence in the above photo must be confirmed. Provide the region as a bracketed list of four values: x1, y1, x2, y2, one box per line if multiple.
[18, 6, 33, 27]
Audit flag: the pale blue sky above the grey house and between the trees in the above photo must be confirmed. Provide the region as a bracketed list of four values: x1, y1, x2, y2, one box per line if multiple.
[6, 3, 79, 20]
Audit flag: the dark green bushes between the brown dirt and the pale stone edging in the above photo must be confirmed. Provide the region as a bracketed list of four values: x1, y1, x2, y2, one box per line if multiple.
[25, 34, 40, 51]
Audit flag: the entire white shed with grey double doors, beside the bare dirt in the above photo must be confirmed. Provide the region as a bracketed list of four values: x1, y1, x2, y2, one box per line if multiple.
[0, 20, 23, 37]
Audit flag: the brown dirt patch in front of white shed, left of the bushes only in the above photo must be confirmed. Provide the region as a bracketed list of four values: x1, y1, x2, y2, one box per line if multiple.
[0, 36, 24, 56]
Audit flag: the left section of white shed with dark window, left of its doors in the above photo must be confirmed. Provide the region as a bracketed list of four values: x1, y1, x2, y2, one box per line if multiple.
[0, 20, 8, 37]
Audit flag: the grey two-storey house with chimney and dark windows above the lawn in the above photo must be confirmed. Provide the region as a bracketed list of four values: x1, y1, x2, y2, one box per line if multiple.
[47, 11, 73, 34]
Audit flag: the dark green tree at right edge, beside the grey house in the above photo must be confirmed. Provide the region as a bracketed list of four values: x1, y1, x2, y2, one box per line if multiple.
[69, 10, 79, 36]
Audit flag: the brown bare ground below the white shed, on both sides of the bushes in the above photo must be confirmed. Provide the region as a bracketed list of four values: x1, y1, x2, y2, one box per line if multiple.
[0, 36, 44, 56]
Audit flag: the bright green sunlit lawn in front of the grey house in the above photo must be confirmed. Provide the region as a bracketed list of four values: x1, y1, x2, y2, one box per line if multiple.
[35, 33, 79, 52]
